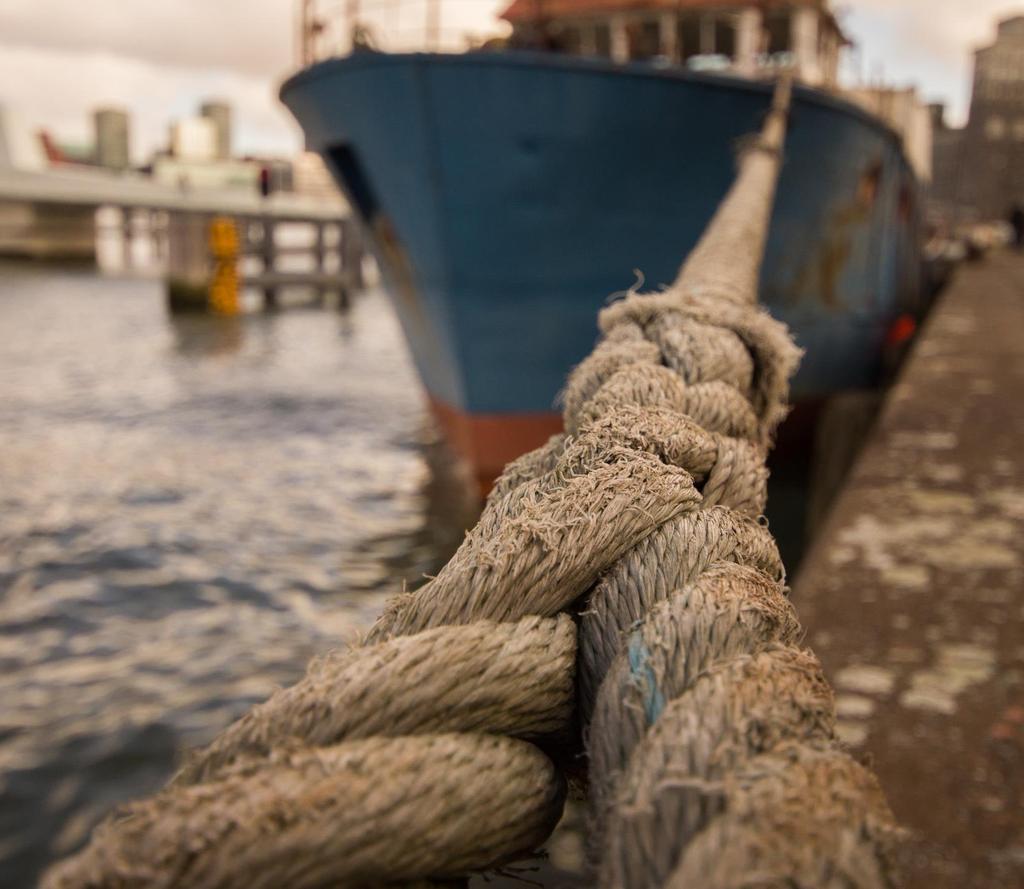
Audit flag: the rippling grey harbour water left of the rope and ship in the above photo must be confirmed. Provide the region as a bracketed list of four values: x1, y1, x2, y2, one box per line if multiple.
[0, 264, 468, 889]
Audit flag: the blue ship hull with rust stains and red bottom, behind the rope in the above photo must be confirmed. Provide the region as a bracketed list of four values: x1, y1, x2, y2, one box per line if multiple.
[282, 53, 921, 483]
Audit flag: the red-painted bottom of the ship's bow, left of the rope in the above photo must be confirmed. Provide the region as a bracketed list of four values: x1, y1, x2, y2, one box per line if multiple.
[430, 397, 562, 495]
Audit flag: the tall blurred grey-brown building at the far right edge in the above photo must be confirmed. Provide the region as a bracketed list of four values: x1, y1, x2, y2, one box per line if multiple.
[953, 15, 1024, 218]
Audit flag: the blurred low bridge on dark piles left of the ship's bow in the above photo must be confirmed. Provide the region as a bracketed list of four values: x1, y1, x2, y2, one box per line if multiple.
[0, 157, 362, 305]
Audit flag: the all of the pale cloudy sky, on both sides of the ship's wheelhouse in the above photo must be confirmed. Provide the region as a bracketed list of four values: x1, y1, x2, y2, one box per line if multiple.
[0, 0, 1024, 159]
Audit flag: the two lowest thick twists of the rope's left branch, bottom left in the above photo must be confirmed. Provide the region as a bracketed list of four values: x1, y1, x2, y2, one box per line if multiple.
[43, 603, 575, 889]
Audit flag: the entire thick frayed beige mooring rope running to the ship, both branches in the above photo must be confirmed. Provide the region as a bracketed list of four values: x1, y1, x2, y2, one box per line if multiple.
[44, 76, 901, 887]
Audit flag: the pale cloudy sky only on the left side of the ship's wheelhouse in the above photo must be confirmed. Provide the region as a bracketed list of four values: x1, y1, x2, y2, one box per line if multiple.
[0, 0, 503, 160]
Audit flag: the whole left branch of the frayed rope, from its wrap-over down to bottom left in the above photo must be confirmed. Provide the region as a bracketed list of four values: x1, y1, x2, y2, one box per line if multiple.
[45, 329, 765, 887]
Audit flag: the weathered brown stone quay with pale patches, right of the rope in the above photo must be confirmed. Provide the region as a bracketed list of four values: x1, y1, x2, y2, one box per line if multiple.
[794, 254, 1024, 889]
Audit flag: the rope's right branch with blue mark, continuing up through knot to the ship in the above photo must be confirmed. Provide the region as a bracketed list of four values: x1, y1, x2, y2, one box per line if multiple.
[483, 79, 897, 889]
